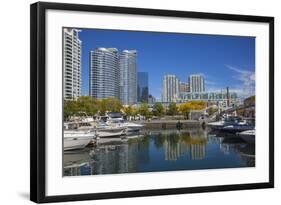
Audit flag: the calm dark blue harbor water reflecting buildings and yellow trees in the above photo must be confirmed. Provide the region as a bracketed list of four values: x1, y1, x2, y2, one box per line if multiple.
[64, 129, 255, 176]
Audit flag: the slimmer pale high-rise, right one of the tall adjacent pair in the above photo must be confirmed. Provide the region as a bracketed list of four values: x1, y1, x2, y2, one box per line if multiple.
[119, 50, 137, 105]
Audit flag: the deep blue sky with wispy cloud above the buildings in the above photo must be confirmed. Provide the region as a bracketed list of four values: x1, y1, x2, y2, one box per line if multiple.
[79, 29, 255, 99]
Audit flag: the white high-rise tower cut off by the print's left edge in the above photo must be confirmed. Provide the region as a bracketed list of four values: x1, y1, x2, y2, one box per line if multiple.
[63, 28, 82, 100]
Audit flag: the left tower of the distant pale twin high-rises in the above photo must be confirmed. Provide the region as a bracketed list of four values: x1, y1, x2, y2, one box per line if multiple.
[162, 75, 179, 102]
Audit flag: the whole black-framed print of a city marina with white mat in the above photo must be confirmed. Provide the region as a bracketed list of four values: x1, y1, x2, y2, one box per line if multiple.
[30, 2, 274, 203]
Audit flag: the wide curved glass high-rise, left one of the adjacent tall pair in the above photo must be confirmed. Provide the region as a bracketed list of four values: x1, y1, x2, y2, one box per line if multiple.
[89, 48, 120, 99]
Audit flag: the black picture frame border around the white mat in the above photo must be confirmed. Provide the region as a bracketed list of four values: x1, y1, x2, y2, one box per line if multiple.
[30, 2, 274, 203]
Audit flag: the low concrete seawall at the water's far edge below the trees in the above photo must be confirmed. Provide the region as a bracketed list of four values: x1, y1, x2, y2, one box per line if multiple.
[137, 120, 206, 129]
